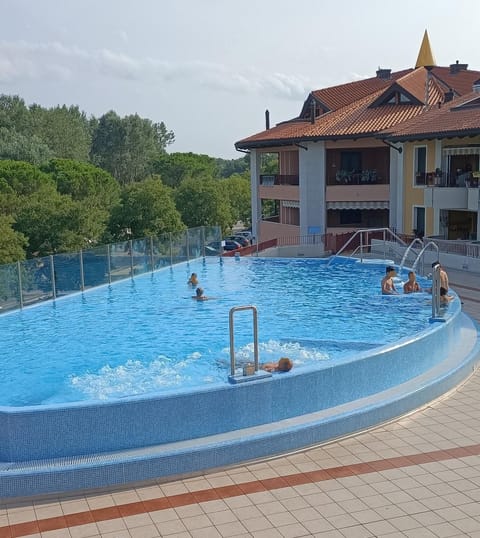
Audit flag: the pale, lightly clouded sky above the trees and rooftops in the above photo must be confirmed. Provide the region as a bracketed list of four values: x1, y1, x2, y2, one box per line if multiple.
[0, 0, 480, 159]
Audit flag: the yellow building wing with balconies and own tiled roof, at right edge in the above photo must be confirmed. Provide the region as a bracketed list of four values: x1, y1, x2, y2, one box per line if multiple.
[386, 85, 480, 240]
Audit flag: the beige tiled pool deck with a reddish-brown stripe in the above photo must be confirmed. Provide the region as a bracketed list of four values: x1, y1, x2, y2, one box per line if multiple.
[0, 270, 480, 538]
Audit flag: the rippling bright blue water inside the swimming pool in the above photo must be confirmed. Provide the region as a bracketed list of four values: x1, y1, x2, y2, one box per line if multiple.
[0, 254, 431, 406]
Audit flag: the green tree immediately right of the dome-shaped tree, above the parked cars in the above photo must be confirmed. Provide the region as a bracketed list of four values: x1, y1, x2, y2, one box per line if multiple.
[175, 179, 234, 233]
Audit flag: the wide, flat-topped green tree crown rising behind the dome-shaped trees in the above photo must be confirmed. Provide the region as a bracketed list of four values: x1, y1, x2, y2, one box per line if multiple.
[153, 153, 218, 187]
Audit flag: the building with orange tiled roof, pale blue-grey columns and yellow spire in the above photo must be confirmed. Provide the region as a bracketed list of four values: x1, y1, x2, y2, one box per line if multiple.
[235, 32, 480, 241]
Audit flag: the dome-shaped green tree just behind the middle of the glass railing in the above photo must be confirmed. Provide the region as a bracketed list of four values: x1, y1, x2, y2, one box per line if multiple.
[110, 177, 185, 239]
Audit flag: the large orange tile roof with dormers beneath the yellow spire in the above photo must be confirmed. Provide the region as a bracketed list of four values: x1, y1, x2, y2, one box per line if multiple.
[235, 67, 480, 149]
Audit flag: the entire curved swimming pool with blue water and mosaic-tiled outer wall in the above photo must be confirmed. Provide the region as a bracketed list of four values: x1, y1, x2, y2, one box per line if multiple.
[0, 258, 480, 497]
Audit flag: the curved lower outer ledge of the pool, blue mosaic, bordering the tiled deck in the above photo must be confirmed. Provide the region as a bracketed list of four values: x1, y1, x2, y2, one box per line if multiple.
[0, 313, 480, 497]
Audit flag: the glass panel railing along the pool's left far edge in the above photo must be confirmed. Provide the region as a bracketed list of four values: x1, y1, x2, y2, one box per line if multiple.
[0, 226, 222, 312]
